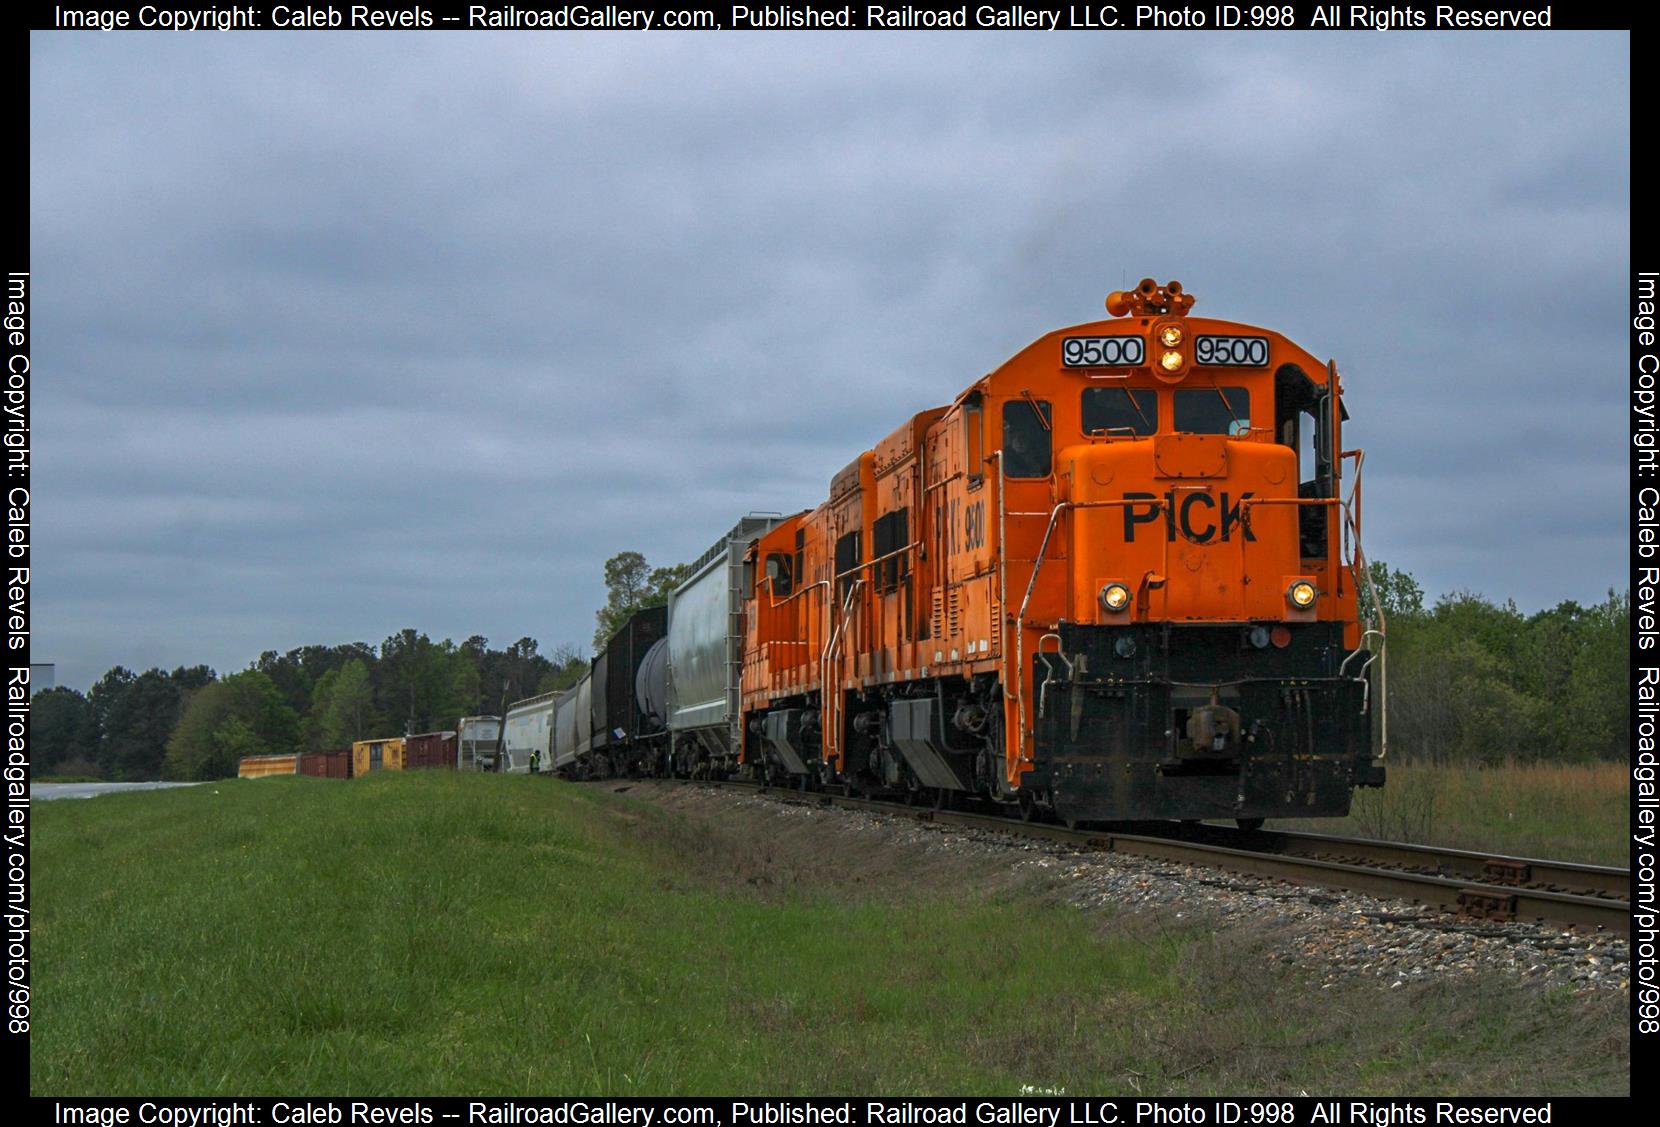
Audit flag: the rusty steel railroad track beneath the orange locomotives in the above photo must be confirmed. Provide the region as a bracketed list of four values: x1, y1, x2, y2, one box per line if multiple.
[657, 780, 1632, 936]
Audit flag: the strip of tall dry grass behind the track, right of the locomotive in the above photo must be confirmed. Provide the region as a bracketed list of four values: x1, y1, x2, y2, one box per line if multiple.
[1270, 764, 1632, 865]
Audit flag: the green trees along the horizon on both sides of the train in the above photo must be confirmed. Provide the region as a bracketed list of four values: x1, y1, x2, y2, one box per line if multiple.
[30, 551, 1630, 780]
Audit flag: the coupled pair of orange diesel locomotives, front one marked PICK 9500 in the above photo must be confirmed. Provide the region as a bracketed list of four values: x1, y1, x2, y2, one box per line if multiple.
[743, 279, 1383, 827]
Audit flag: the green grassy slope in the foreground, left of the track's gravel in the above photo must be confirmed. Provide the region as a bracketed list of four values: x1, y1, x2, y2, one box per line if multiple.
[30, 773, 1630, 1095]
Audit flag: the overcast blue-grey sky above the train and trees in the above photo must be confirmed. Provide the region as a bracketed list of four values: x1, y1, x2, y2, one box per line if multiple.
[30, 32, 1630, 689]
